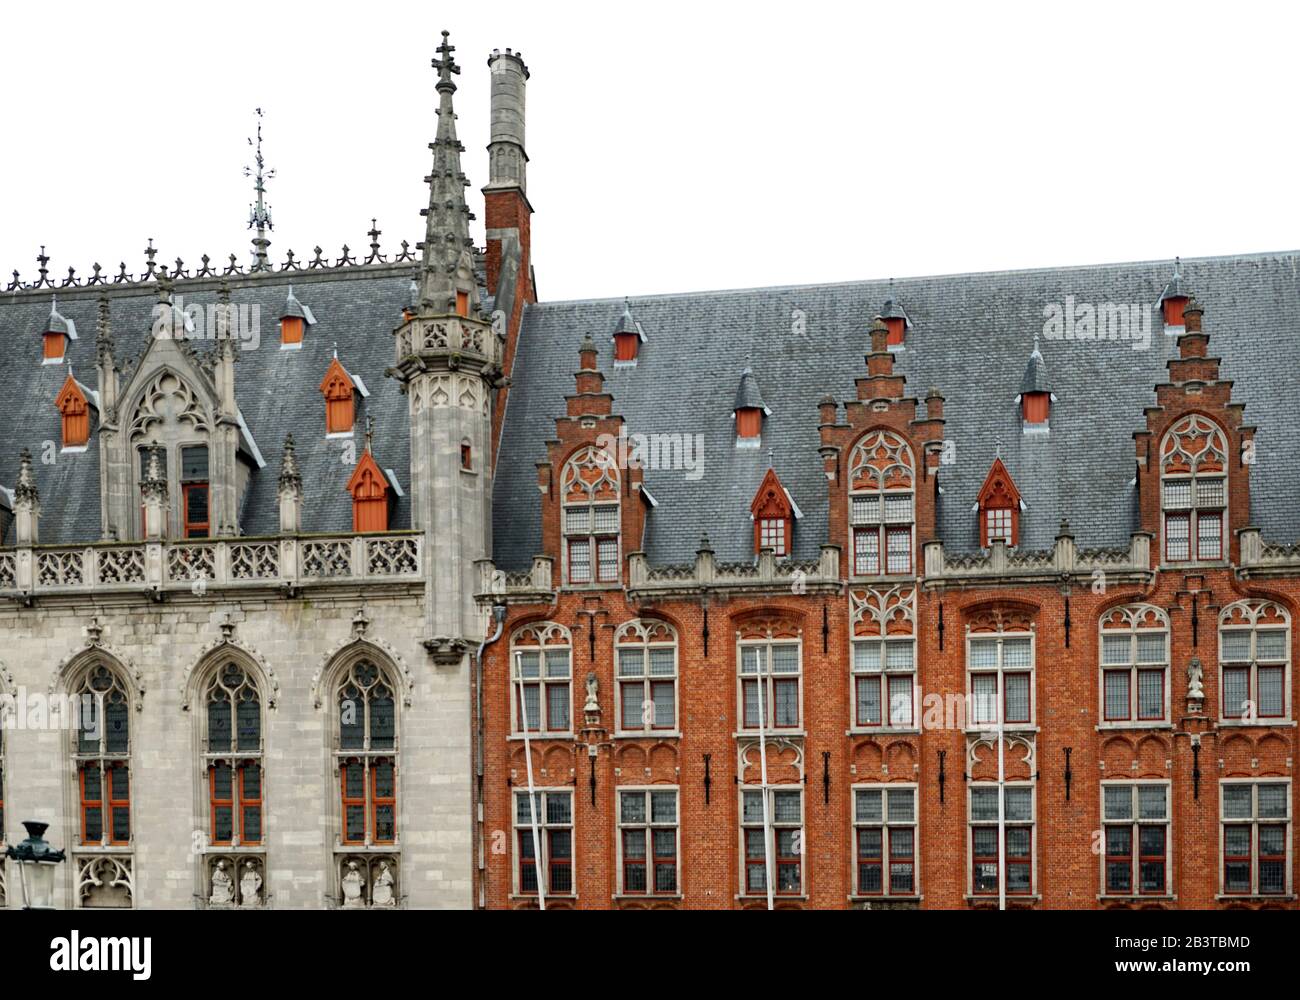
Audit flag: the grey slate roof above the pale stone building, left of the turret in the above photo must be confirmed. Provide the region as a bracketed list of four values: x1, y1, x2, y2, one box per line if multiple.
[0, 264, 412, 544]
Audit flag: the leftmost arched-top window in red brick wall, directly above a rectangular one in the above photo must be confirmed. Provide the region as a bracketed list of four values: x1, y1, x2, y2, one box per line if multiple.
[510, 622, 573, 735]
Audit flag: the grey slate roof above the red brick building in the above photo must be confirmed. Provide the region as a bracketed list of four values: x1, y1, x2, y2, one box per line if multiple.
[494, 252, 1300, 570]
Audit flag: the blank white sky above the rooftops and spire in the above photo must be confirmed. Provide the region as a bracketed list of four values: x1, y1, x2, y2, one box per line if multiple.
[0, 0, 1300, 299]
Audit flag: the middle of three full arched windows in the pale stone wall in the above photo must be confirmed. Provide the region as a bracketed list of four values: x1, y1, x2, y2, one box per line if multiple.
[203, 661, 264, 847]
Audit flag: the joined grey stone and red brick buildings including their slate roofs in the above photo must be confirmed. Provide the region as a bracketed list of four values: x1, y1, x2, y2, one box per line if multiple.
[0, 38, 1300, 909]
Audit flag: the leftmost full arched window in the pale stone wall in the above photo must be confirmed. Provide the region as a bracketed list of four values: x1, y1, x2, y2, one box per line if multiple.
[72, 662, 131, 847]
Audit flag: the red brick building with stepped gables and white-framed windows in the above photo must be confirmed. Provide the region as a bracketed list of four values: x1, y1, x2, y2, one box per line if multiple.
[478, 275, 1300, 909]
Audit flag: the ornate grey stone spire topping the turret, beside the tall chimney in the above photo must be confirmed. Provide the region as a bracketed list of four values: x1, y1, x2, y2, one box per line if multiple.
[420, 31, 477, 313]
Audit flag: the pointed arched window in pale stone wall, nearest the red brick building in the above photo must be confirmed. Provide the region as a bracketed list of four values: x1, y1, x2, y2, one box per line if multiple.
[334, 658, 398, 847]
